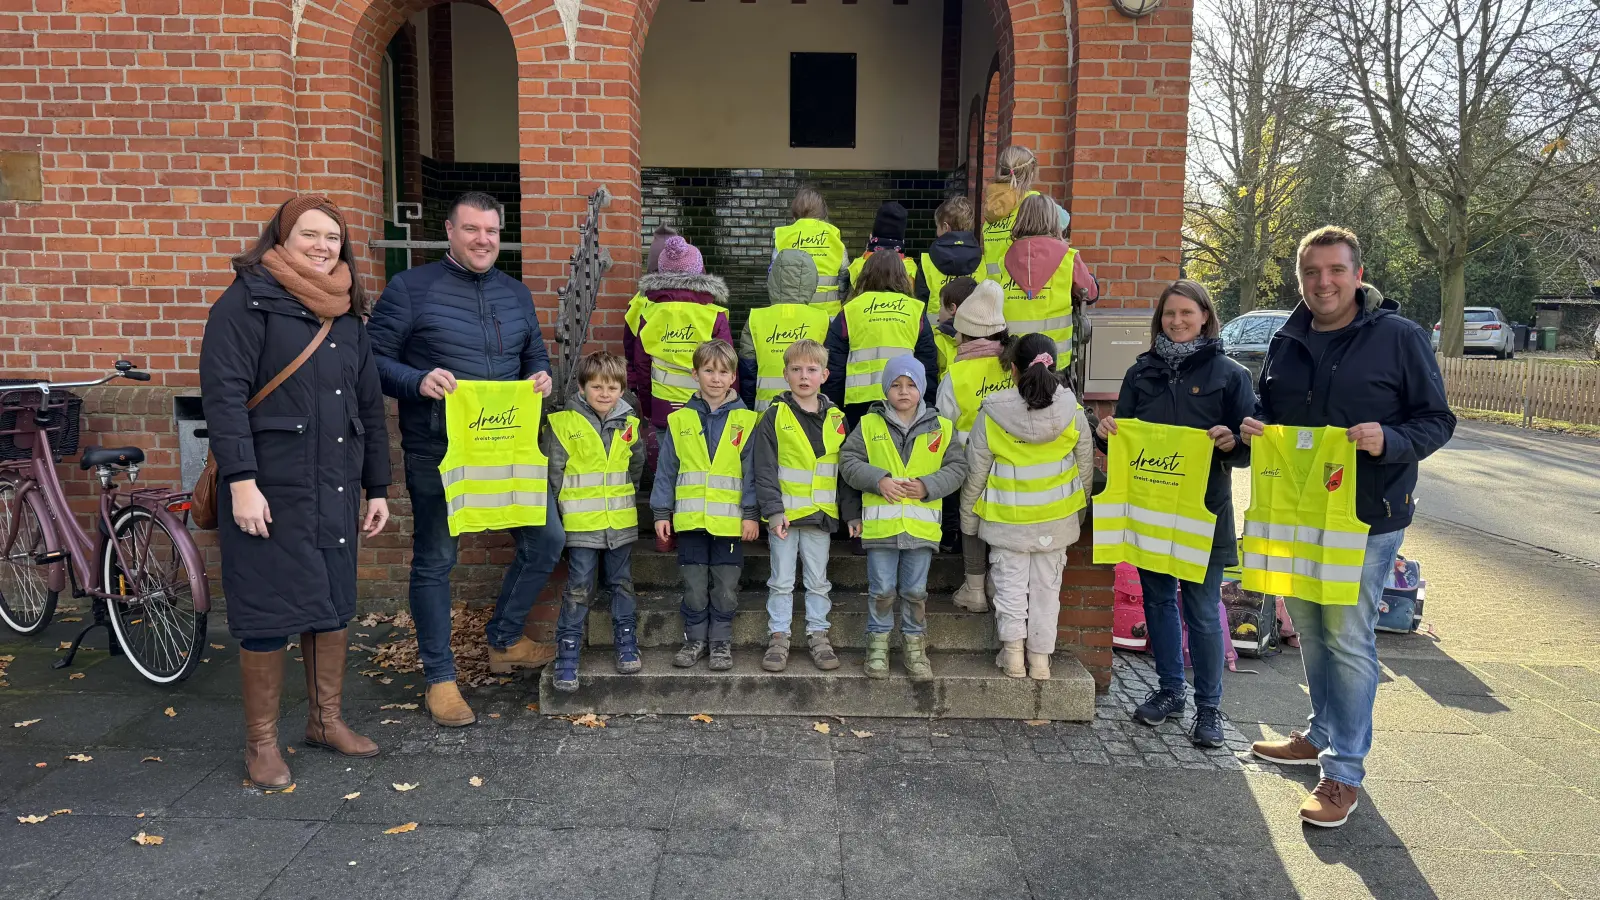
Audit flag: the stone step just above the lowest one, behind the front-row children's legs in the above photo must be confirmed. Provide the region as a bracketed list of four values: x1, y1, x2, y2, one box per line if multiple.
[589, 591, 1000, 650]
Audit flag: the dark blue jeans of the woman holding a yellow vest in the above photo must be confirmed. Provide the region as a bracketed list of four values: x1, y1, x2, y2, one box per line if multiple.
[1139, 560, 1227, 706]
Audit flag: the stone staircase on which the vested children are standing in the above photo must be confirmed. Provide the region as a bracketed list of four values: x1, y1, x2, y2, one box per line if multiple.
[539, 511, 1094, 721]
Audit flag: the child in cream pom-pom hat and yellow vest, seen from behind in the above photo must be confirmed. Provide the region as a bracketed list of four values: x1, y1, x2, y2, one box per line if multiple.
[934, 279, 1013, 612]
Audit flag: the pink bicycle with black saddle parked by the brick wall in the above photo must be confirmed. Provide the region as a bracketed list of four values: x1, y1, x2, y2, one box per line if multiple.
[0, 360, 211, 684]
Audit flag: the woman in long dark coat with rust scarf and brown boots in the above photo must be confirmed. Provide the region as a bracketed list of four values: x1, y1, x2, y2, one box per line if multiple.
[200, 195, 389, 788]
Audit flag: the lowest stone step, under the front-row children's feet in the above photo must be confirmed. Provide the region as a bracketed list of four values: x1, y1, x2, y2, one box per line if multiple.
[539, 647, 1094, 727]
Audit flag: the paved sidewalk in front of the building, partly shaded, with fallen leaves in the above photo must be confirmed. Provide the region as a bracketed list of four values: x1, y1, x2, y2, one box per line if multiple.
[0, 524, 1600, 900]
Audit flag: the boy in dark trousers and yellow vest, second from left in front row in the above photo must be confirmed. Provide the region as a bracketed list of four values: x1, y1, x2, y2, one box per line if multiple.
[650, 341, 760, 671]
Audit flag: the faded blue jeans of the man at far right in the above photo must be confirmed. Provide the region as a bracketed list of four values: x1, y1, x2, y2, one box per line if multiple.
[1283, 528, 1405, 788]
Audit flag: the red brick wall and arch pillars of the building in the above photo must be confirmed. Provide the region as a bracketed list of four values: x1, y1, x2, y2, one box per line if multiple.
[0, 0, 1190, 677]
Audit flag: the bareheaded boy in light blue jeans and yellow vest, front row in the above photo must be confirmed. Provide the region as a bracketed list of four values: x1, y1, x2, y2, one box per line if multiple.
[750, 341, 859, 673]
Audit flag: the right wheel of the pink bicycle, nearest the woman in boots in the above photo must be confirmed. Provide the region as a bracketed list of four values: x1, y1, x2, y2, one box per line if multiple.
[101, 506, 206, 684]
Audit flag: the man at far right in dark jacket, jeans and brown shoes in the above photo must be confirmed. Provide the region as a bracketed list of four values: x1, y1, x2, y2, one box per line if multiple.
[1240, 226, 1456, 828]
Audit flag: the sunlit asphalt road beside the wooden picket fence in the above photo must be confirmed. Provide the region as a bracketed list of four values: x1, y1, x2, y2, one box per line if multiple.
[1416, 420, 1600, 562]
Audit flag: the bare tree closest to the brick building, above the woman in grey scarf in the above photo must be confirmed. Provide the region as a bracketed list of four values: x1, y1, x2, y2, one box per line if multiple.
[1186, 0, 1310, 312]
